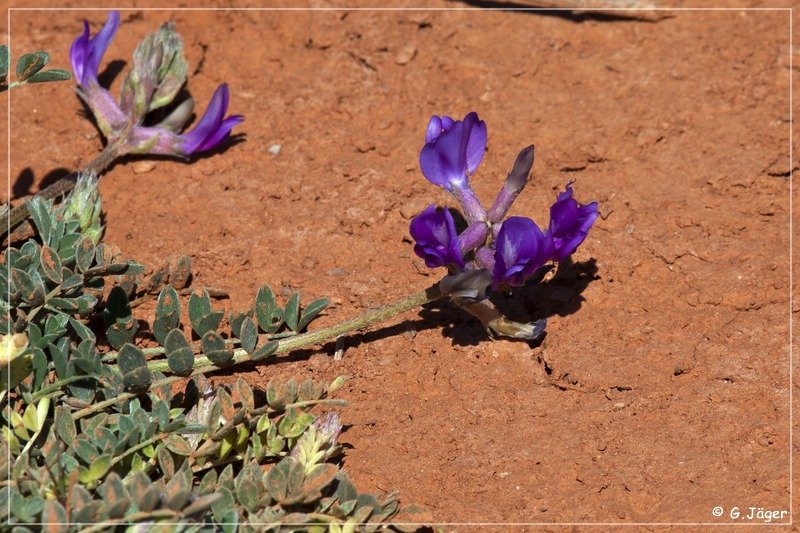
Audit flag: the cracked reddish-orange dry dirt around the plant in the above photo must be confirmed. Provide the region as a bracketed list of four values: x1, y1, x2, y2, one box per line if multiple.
[0, 0, 798, 522]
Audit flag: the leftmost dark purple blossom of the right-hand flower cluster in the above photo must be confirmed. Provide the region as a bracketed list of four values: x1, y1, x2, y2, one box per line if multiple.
[410, 204, 464, 269]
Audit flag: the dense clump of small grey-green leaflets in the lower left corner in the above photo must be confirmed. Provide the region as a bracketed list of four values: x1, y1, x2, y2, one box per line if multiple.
[0, 177, 424, 531]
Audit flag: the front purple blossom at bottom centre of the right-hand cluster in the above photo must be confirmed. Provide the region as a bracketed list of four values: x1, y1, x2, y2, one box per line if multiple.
[492, 217, 552, 290]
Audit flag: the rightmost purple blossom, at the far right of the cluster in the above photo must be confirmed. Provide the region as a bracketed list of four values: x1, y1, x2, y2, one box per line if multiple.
[547, 181, 600, 261]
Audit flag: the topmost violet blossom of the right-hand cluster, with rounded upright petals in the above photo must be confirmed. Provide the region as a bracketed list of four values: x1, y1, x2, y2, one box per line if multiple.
[419, 112, 486, 192]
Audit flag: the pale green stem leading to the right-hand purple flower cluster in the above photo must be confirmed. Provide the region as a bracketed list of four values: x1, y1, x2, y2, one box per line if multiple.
[72, 282, 444, 420]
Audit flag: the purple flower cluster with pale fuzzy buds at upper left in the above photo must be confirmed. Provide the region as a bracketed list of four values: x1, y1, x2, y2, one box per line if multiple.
[70, 11, 244, 157]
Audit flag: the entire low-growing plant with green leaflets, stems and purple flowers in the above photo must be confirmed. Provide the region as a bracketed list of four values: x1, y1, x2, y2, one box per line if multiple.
[0, 12, 598, 531]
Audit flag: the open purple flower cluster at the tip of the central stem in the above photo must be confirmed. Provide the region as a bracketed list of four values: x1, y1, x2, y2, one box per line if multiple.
[410, 112, 600, 289]
